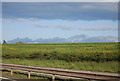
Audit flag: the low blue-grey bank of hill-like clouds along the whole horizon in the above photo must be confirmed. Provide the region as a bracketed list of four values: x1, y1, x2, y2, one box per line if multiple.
[7, 35, 118, 43]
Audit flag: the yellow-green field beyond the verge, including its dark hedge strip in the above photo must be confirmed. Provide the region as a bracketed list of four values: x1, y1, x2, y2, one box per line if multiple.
[2, 43, 120, 62]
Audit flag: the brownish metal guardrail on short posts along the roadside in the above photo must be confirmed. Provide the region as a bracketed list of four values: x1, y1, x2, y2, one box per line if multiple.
[0, 63, 120, 81]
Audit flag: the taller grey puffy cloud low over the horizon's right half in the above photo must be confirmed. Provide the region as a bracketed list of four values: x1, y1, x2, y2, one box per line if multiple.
[68, 34, 118, 42]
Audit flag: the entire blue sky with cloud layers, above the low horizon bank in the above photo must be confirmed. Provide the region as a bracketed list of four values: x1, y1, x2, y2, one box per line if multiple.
[2, 0, 118, 41]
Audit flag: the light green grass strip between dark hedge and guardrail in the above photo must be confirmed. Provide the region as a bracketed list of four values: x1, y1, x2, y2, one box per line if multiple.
[3, 59, 119, 73]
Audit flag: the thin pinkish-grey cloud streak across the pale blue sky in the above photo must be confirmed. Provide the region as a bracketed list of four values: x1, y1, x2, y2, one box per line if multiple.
[33, 24, 118, 30]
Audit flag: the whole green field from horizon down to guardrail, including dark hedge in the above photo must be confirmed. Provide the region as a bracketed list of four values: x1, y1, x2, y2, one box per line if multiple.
[2, 43, 120, 72]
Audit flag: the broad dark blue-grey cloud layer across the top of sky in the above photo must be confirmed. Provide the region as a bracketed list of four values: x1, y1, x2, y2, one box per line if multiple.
[3, 2, 118, 20]
